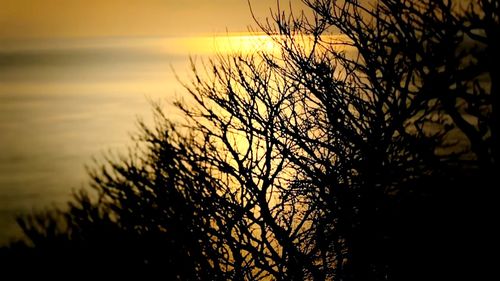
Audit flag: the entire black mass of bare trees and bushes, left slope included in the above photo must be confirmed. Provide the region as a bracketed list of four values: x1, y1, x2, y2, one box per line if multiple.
[0, 0, 500, 280]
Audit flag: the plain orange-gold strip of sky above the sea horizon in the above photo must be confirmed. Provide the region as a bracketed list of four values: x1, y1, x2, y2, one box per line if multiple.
[0, 0, 299, 39]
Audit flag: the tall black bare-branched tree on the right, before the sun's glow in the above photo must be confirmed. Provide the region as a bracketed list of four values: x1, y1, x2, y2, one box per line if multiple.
[178, 1, 498, 280]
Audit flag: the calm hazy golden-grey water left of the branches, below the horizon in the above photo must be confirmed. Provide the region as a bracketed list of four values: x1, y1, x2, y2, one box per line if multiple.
[0, 38, 198, 244]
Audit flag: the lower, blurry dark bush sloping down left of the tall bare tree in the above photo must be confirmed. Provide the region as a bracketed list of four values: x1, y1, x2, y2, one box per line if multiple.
[2, 113, 229, 280]
